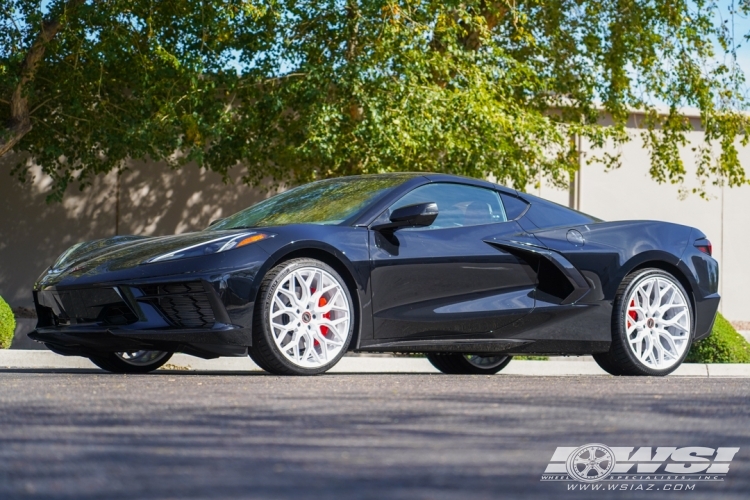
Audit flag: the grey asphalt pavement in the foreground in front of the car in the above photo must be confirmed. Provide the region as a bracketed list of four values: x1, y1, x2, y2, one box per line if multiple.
[0, 369, 750, 500]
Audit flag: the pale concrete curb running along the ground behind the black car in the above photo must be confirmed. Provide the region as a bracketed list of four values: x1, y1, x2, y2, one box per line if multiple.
[0, 350, 750, 378]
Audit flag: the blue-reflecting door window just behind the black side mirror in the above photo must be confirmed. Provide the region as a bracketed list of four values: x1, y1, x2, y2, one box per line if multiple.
[391, 183, 508, 229]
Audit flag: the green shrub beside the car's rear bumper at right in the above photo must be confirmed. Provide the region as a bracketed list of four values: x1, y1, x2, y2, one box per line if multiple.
[685, 313, 750, 363]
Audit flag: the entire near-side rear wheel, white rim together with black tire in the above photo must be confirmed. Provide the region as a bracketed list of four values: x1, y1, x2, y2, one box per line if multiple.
[594, 269, 694, 376]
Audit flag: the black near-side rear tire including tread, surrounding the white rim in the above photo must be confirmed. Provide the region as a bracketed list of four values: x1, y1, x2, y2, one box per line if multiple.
[594, 268, 695, 377]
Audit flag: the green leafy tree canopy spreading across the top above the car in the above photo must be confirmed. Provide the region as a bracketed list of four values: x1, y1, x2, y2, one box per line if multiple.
[0, 0, 747, 199]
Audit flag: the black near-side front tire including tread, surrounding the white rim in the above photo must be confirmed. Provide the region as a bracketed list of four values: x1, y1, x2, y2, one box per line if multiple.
[249, 258, 357, 375]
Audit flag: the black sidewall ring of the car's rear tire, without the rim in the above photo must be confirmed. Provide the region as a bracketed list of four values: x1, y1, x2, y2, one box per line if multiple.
[612, 269, 695, 376]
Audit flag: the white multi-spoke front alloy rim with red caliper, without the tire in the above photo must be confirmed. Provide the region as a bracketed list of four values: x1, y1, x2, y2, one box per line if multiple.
[267, 266, 352, 368]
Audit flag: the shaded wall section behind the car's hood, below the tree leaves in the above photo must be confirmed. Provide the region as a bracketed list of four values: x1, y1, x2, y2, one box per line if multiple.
[0, 157, 266, 308]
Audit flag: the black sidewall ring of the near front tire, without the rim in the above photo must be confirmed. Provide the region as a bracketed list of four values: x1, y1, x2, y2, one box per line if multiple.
[256, 259, 357, 375]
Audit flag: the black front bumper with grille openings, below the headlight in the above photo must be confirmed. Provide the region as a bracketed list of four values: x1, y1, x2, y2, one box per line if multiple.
[29, 278, 253, 355]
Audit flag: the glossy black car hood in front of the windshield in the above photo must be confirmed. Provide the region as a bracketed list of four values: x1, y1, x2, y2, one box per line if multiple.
[37, 230, 254, 287]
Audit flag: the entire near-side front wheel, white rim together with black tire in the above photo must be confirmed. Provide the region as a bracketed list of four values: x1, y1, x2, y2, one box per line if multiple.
[250, 258, 354, 375]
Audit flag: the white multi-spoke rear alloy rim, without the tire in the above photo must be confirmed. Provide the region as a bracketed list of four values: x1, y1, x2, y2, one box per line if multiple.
[624, 275, 692, 370]
